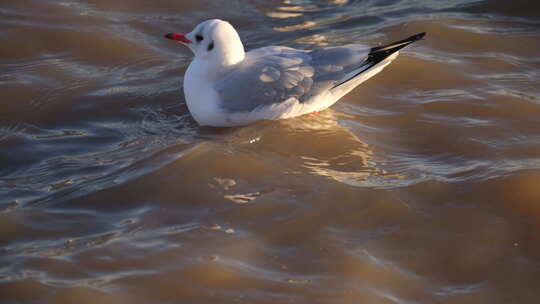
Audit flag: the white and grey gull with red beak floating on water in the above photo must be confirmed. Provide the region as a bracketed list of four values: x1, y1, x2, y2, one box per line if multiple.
[165, 19, 426, 127]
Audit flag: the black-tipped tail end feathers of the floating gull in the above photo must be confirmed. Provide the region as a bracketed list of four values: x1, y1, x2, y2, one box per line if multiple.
[332, 32, 426, 89]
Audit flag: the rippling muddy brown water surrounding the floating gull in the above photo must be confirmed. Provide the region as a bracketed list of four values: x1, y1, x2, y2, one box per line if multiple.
[0, 0, 540, 304]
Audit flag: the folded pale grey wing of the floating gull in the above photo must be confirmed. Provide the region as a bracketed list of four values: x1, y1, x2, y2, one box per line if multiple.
[215, 45, 369, 112]
